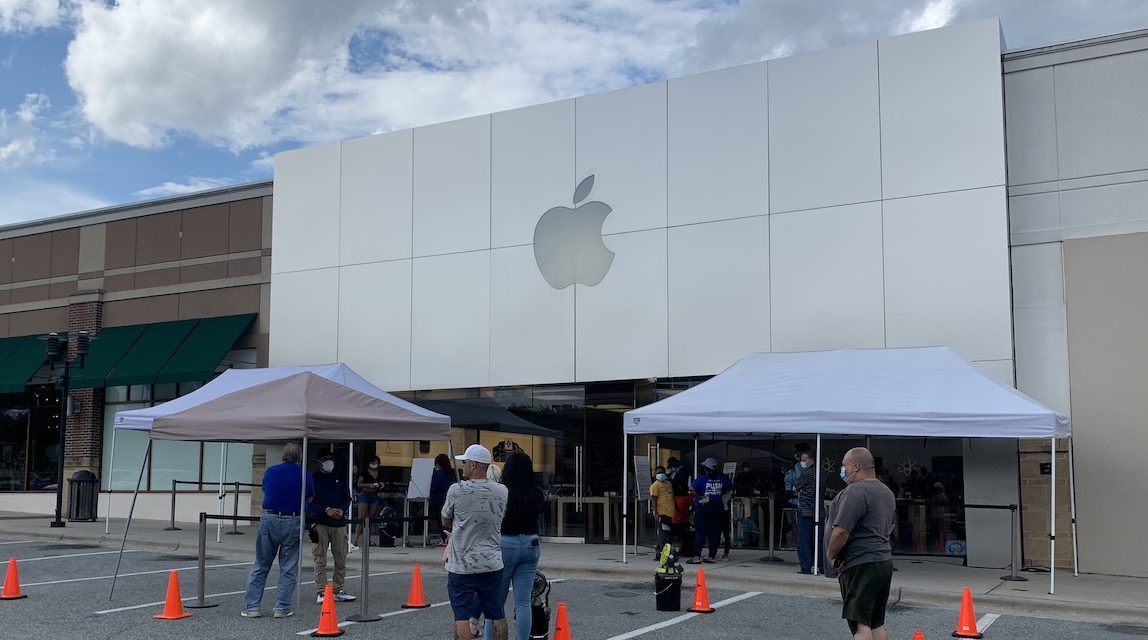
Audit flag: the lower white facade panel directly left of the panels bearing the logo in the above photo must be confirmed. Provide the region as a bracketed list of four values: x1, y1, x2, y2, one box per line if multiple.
[411, 252, 490, 388]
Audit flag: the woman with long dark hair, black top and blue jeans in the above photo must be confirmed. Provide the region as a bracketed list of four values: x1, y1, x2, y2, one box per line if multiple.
[486, 450, 545, 640]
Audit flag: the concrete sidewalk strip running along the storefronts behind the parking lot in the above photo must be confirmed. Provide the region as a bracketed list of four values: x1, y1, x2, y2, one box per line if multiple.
[0, 511, 1148, 626]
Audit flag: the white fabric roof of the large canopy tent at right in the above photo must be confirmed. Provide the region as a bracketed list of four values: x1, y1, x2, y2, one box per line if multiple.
[622, 347, 1071, 438]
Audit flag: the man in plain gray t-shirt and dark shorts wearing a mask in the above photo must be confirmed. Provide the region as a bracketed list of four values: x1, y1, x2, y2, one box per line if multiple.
[825, 447, 897, 640]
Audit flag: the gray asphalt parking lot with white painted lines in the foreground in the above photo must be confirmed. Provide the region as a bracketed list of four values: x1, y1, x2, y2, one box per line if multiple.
[0, 541, 1145, 640]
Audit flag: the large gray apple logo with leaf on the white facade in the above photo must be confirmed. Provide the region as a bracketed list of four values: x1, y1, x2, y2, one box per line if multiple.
[534, 175, 614, 290]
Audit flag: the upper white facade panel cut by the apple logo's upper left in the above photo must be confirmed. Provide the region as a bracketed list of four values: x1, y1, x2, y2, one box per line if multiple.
[490, 100, 577, 247]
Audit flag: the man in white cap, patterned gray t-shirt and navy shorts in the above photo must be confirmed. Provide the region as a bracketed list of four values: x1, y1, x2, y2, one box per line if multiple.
[441, 445, 507, 640]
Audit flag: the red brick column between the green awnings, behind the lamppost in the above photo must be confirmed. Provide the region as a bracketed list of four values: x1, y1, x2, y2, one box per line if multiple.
[64, 292, 103, 510]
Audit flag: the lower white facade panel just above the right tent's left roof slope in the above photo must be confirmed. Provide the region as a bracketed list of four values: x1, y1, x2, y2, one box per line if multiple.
[668, 216, 769, 376]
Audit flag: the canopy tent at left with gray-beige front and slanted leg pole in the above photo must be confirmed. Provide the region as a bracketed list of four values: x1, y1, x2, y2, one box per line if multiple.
[109, 364, 450, 600]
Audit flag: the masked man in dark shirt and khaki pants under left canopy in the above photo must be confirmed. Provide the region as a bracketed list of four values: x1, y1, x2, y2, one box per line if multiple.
[309, 449, 355, 604]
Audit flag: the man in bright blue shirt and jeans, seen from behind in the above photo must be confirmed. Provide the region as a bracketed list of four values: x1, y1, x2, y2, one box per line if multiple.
[241, 442, 315, 618]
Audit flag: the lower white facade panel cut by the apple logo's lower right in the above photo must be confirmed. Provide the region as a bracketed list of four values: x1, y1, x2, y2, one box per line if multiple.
[574, 229, 669, 380]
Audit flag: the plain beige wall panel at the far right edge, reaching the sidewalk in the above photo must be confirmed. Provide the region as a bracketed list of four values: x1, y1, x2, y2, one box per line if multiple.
[1064, 233, 1148, 576]
